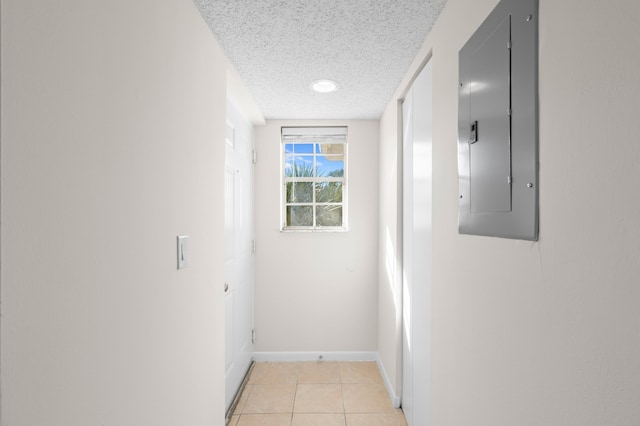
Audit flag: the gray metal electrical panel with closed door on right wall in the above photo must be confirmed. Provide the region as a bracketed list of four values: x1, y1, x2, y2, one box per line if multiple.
[458, 0, 538, 240]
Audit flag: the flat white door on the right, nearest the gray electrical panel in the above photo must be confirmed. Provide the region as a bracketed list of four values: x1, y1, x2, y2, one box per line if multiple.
[402, 62, 432, 426]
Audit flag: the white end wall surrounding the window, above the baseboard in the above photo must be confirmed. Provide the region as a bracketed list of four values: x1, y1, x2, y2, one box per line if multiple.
[255, 120, 379, 353]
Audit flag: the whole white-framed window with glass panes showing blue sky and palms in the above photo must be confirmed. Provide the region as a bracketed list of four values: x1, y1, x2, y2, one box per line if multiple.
[282, 127, 347, 231]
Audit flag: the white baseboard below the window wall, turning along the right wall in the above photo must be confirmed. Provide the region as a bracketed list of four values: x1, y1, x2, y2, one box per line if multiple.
[253, 352, 400, 408]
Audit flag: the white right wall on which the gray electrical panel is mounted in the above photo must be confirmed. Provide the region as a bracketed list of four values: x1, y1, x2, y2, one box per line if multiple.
[379, 0, 640, 426]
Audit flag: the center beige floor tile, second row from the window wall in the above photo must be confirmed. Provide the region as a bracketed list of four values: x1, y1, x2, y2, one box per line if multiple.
[293, 383, 344, 413]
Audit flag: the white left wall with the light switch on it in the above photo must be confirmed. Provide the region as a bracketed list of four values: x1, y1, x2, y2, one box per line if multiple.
[0, 0, 235, 426]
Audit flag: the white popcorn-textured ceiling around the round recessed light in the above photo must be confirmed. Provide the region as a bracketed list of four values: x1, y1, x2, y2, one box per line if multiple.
[194, 0, 446, 119]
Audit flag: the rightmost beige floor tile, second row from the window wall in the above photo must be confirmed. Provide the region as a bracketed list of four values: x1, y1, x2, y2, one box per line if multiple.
[342, 383, 394, 414]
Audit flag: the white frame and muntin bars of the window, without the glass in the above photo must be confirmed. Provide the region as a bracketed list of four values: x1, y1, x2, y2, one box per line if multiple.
[280, 126, 348, 232]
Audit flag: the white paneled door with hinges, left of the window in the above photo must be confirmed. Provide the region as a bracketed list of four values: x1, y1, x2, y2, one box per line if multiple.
[224, 102, 253, 409]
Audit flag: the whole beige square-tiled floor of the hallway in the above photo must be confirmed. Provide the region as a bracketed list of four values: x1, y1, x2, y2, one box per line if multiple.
[229, 361, 407, 426]
